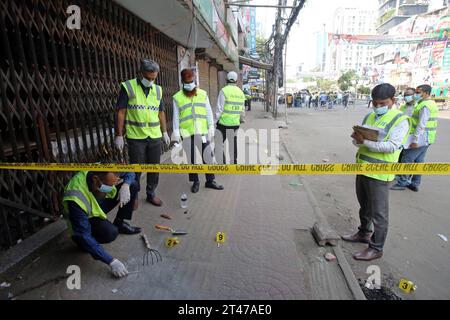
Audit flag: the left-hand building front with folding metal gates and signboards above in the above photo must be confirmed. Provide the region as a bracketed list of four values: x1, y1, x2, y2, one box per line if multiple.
[0, 0, 242, 250]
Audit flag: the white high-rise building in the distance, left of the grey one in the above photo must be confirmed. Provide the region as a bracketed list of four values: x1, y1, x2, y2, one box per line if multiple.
[326, 8, 376, 74]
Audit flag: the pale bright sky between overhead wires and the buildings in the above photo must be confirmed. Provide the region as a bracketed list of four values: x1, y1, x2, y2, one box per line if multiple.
[255, 0, 378, 78]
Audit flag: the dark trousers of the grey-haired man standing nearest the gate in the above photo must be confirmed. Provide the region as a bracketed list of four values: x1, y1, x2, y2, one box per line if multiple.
[128, 138, 161, 198]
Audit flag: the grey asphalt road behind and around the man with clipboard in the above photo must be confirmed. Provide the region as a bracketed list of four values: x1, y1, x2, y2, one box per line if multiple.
[280, 105, 450, 299]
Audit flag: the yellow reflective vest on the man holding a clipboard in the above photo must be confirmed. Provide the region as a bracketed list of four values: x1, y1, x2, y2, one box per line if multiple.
[356, 110, 408, 181]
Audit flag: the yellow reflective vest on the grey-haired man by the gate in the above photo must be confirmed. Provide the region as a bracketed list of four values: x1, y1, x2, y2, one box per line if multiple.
[122, 79, 162, 139]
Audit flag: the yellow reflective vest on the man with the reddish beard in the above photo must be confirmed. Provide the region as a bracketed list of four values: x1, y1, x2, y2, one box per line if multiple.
[173, 89, 208, 138]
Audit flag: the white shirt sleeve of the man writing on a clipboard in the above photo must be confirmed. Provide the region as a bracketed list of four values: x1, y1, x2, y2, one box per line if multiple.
[353, 112, 409, 153]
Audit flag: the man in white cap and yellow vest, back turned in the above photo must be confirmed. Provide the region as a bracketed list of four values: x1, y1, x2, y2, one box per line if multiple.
[216, 71, 245, 164]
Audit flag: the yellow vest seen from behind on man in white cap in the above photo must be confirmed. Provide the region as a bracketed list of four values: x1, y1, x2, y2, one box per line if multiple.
[219, 85, 245, 127]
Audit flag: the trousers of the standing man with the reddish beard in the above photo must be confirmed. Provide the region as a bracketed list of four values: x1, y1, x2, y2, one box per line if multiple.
[183, 135, 216, 182]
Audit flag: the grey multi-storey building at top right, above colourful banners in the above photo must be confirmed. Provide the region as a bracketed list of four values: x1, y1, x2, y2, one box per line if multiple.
[377, 0, 430, 34]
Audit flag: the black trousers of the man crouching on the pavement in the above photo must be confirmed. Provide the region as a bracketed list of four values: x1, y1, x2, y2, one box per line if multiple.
[89, 183, 139, 244]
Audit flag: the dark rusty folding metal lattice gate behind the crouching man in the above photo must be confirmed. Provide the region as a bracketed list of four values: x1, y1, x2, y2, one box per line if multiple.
[0, 0, 179, 248]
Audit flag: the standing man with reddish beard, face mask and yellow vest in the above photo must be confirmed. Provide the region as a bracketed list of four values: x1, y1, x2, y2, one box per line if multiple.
[173, 69, 223, 193]
